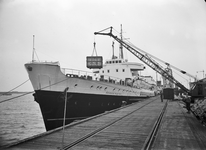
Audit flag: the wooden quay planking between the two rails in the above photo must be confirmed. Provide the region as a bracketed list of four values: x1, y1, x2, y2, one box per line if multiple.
[72, 100, 165, 150]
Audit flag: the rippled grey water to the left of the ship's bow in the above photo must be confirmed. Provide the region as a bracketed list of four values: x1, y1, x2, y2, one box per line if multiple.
[0, 94, 46, 147]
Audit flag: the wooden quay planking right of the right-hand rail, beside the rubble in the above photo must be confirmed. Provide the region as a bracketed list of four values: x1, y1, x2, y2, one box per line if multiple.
[153, 102, 206, 150]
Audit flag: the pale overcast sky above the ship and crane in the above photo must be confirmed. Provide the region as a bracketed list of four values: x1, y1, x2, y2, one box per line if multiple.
[0, 0, 206, 91]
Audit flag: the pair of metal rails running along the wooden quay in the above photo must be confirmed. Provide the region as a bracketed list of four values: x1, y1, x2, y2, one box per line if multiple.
[61, 99, 167, 150]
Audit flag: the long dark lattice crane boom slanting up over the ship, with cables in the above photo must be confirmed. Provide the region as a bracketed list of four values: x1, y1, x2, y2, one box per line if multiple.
[94, 27, 191, 94]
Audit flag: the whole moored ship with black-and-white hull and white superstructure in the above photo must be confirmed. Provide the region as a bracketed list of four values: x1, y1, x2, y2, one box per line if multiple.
[25, 29, 156, 131]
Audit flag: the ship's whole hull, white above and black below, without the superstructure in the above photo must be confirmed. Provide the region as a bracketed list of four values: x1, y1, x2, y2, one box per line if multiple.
[25, 62, 154, 131]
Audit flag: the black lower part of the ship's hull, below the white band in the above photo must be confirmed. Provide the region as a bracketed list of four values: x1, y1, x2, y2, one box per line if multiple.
[34, 90, 137, 131]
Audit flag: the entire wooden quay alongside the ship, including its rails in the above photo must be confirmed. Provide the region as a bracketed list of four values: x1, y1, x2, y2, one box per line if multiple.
[3, 96, 206, 150]
